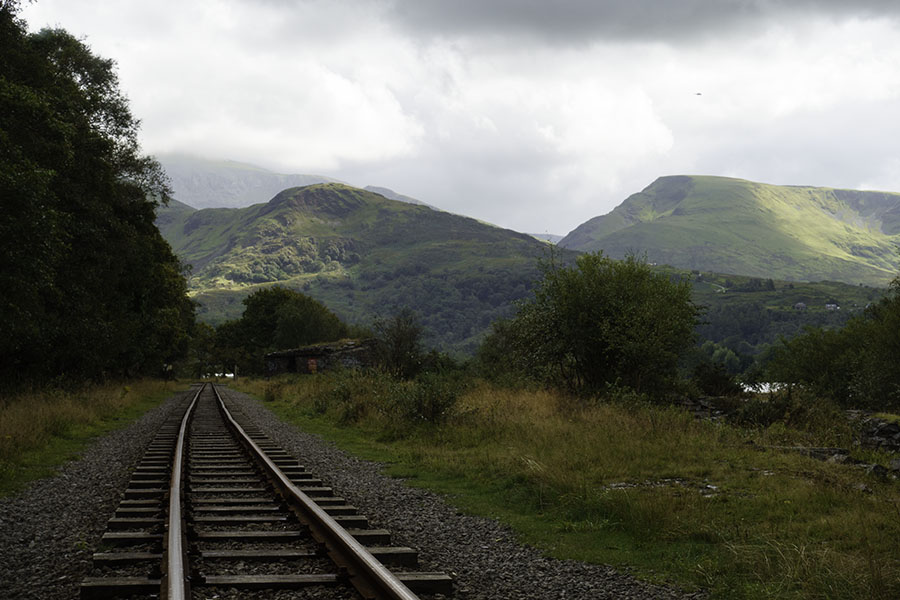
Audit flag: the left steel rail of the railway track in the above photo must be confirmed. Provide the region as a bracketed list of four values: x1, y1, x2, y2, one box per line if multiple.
[160, 383, 207, 600]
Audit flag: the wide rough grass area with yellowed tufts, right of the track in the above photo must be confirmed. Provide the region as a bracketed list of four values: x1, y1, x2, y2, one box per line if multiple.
[238, 374, 900, 599]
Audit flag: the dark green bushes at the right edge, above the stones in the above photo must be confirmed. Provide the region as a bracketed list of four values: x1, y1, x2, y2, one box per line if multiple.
[768, 278, 900, 410]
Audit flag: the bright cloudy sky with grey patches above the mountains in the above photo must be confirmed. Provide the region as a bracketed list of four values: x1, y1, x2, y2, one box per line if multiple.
[22, 0, 900, 234]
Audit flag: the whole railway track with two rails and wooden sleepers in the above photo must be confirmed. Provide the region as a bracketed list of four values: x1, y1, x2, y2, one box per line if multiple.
[81, 384, 452, 600]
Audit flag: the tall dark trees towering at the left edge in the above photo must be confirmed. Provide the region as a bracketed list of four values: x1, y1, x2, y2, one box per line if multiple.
[0, 2, 194, 385]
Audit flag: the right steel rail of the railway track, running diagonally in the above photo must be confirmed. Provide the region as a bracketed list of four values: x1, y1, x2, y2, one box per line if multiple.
[211, 384, 419, 600]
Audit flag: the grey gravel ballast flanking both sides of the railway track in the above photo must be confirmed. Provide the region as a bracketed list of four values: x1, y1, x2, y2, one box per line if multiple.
[0, 390, 702, 600]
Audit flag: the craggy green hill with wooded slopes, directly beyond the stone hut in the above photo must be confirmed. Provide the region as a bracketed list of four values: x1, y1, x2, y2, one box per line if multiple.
[157, 183, 560, 351]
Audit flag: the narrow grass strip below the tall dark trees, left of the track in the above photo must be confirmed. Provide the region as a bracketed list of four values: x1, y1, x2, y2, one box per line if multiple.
[0, 380, 184, 496]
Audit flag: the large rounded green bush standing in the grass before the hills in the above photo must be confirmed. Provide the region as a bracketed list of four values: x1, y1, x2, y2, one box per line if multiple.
[481, 253, 699, 394]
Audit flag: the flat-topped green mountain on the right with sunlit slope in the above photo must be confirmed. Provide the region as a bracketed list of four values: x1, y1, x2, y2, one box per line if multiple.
[559, 176, 900, 285]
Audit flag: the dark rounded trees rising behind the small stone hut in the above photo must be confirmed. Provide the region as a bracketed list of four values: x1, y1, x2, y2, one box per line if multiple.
[215, 285, 351, 373]
